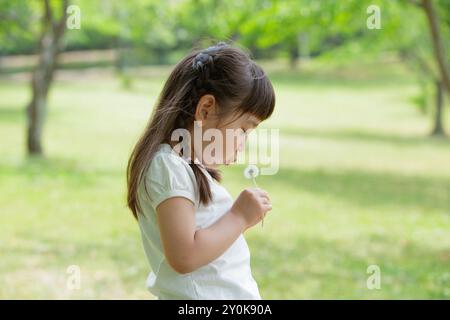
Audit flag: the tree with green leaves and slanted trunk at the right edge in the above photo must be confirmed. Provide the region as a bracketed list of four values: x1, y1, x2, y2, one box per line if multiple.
[328, 0, 450, 135]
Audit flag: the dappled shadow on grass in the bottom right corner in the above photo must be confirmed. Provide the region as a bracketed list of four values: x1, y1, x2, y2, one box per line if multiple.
[249, 234, 449, 299]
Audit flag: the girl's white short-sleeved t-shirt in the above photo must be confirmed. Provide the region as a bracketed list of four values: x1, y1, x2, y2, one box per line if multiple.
[138, 143, 261, 300]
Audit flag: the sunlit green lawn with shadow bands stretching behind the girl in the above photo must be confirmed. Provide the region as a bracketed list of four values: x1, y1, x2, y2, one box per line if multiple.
[0, 60, 450, 299]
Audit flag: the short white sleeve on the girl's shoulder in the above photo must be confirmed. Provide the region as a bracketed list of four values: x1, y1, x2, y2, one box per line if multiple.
[145, 153, 196, 210]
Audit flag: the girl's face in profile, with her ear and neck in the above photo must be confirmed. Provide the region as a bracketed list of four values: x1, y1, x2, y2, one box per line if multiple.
[194, 96, 261, 168]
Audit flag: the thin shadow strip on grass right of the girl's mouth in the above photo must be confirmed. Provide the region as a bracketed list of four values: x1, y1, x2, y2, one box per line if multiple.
[280, 128, 450, 147]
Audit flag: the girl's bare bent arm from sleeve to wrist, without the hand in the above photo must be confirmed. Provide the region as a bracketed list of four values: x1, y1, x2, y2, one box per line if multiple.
[156, 197, 246, 274]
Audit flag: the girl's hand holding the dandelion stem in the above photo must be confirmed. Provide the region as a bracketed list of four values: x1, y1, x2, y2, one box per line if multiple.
[230, 188, 272, 231]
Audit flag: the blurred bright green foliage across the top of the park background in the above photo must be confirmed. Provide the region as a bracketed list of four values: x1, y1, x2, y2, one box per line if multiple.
[0, 0, 450, 72]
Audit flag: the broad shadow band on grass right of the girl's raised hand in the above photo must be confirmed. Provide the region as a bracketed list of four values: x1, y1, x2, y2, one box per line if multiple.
[229, 167, 450, 214]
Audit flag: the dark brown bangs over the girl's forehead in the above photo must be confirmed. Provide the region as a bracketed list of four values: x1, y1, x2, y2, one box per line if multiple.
[237, 61, 275, 121]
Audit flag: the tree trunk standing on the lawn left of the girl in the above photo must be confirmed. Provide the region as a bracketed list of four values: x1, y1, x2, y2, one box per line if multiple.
[27, 0, 67, 155]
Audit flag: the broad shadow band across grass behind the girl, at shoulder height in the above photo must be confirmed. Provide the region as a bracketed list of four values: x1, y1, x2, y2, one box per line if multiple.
[4, 151, 450, 214]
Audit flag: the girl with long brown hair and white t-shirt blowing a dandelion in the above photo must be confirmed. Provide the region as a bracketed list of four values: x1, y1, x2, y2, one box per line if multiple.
[127, 43, 275, 299]
